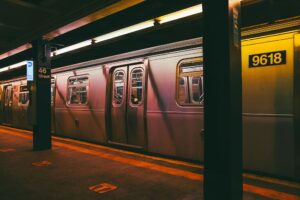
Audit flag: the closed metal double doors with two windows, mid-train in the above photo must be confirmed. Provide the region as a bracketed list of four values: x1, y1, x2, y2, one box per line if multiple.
[110, 64, 146, 148]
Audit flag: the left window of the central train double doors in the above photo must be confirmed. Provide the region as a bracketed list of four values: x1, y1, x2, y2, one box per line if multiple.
[113, 70, 125, 105]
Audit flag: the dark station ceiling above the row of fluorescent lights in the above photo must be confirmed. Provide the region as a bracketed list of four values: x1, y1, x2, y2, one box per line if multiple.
[0, 0, 300, 66]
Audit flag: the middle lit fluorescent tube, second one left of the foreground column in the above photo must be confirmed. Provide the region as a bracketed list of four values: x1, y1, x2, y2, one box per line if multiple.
[94, 20, 154, 43]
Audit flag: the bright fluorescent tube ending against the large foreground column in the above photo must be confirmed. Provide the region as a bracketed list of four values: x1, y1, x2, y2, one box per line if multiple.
[156, 4, 202, 24]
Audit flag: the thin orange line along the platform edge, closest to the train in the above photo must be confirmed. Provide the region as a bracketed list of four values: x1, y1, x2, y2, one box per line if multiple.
[0, 126, 203, 169]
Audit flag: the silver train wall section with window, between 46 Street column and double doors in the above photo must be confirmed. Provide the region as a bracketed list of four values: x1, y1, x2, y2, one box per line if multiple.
[55, 67, 106, 142]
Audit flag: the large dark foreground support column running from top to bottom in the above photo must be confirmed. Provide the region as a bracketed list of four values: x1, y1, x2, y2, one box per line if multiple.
[203, 0, 243, 200]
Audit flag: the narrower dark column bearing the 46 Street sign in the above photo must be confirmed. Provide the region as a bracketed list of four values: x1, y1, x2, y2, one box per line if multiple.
[31, 40, 52, 151]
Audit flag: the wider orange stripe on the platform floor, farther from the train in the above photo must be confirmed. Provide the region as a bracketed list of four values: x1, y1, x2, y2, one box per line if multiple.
[1, 127, 300, 200]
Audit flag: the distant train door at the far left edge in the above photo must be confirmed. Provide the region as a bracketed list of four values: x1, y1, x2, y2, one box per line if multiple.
[3, 85, 13, 124]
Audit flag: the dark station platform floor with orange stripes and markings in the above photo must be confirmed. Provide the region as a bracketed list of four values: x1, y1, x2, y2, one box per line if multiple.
[0, 126, 300, 200]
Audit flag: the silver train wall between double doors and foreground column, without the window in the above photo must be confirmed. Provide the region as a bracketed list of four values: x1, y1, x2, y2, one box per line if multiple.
[147, 49, 203, 160]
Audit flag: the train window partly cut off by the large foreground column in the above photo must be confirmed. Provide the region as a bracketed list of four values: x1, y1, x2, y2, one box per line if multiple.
[177, 58, 204, 105]
